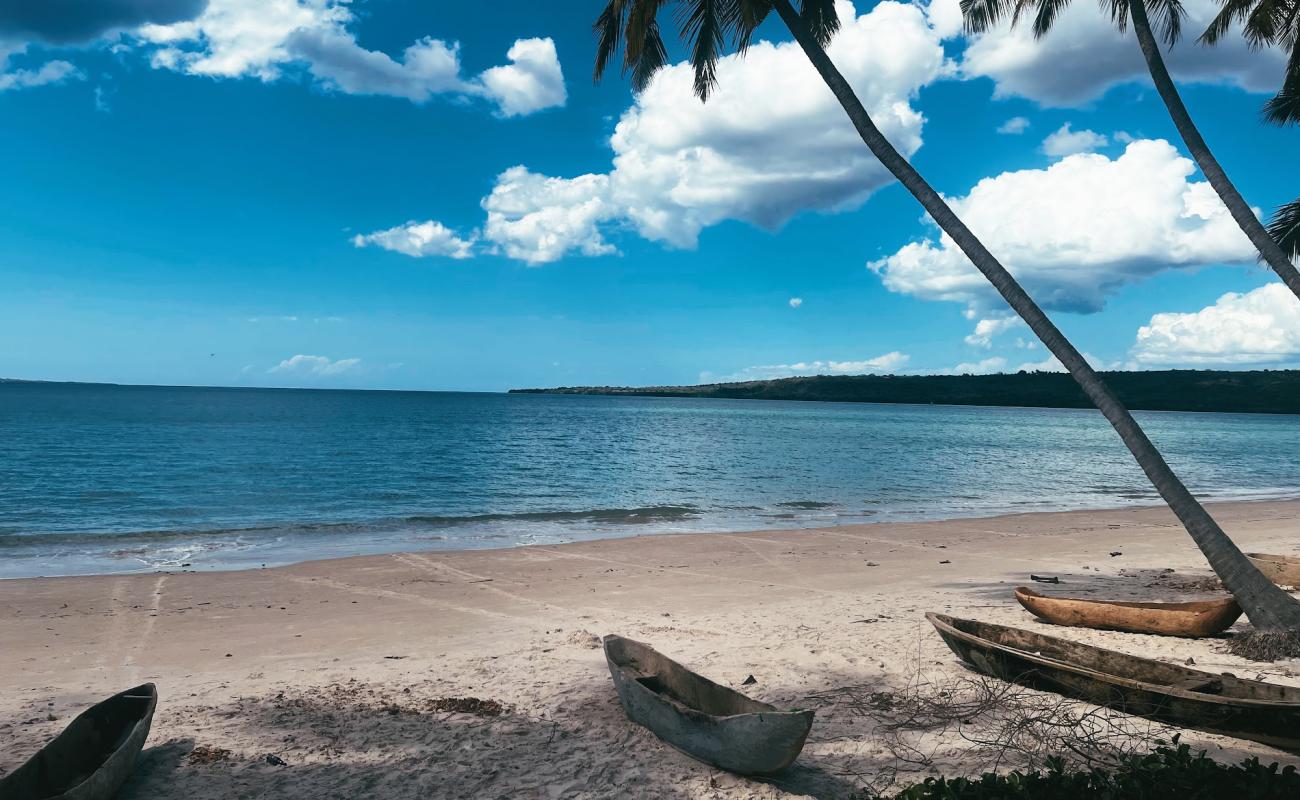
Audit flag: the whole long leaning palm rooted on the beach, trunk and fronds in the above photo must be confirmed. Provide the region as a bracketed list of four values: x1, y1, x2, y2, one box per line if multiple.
[594, 0, 1300, 635]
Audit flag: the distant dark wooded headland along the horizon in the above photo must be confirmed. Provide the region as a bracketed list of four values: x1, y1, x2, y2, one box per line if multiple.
[511, 369, 1300, 415]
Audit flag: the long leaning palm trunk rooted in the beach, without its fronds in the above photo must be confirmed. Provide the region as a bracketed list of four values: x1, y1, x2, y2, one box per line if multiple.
[772, 0, 1300, 631]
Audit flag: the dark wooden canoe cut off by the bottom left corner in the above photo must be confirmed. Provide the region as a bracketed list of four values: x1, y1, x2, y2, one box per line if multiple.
[0, 683, 159, 800]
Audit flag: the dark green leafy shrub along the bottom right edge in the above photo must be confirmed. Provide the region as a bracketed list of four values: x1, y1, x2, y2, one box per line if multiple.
[896, 738, 1300, 800]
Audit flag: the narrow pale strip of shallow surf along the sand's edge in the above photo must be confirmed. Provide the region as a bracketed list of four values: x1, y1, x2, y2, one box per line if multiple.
[10, 492, 1300, 584]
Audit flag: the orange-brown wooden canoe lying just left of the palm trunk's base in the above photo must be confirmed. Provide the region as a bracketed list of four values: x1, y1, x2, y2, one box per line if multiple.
[1015, 587, 1242, 639]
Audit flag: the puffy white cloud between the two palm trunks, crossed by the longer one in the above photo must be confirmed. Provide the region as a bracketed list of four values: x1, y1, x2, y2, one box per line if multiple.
[868, 139, 1255, 317]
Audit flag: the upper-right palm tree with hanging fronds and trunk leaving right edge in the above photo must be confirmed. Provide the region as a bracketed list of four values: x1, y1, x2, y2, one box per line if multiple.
[962, 0, 1300, 299]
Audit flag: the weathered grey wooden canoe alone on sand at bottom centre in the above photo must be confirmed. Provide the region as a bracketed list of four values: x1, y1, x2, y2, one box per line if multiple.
[602, 636, 813, 775]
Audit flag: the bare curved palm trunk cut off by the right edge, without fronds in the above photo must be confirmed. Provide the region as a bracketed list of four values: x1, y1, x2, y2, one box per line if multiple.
[1128, 0, 1300, 299]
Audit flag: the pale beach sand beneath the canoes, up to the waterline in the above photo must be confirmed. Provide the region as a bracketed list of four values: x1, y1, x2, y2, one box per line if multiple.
[0, 502, 1300, 800]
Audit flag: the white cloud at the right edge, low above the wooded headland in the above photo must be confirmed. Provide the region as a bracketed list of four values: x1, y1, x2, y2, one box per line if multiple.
[1132, 284, 1300, 367]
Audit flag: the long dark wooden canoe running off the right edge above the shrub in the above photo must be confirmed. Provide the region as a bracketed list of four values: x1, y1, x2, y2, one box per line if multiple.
[926, 614, 1300, 749]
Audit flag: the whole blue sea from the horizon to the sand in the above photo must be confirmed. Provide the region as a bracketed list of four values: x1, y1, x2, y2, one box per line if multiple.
[0, 384, 1300, 578]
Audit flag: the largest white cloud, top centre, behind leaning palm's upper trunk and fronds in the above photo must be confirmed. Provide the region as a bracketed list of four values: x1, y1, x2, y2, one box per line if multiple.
[441, 0, 949, 264]
